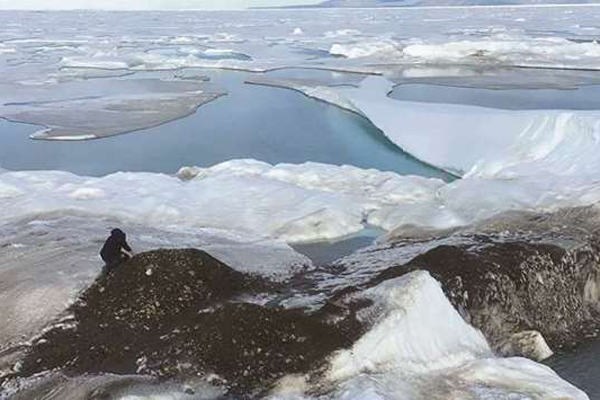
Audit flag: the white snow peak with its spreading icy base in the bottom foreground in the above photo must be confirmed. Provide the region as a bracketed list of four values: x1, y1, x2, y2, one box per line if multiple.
[326, 271, 588, 400]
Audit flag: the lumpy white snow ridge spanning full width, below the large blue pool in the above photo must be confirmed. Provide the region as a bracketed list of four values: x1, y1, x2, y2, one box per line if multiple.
[0, 141, 600, 242]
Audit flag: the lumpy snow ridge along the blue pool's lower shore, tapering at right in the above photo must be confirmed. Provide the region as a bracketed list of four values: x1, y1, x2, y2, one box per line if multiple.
[0, 160, 444, 242]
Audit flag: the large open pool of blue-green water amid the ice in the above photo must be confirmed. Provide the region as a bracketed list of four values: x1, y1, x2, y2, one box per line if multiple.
[0, 71, 452, 180]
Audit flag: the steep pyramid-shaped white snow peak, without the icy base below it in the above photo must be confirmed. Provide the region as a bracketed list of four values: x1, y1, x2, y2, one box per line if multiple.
[329, 272, 492, 380]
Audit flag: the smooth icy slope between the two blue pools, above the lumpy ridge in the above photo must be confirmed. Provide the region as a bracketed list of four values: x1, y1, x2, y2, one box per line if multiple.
[340, 77, 600, 177]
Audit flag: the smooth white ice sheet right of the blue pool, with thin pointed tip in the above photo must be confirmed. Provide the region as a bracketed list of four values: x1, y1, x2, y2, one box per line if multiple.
[246, 77, 600, 231]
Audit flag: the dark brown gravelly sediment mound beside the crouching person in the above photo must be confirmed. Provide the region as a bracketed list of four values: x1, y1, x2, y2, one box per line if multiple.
[16, 249, 352, 398]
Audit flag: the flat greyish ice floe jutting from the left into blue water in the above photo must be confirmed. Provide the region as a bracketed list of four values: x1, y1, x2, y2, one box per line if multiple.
[0, 79, 226, 140]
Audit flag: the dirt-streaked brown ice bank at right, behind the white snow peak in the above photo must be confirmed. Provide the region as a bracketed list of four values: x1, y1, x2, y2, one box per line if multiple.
[334, 206, 600, 352]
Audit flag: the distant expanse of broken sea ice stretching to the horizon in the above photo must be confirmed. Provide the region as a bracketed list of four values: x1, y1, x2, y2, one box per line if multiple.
[0, 5, 600, 86]
